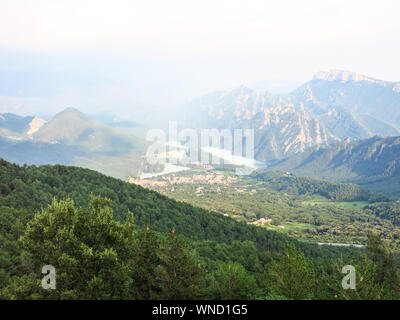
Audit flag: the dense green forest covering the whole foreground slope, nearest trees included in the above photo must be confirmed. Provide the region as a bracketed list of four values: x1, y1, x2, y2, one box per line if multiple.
[0, 160, 400, 299]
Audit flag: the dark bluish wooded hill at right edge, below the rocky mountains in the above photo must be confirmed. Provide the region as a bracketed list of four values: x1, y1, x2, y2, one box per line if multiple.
[269, 136, 400, 196]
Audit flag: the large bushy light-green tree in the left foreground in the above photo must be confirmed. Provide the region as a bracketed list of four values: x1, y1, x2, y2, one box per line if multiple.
[1, 197, 134, 299]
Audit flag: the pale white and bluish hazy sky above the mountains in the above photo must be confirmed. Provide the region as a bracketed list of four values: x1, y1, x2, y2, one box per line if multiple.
[0, 0, 400, 117]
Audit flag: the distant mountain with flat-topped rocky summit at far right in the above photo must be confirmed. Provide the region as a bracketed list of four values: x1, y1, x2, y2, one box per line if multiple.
[290, 70, 400, 139]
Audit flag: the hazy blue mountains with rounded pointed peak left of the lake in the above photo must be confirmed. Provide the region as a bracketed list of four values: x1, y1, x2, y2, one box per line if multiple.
[0, 108, 146, 178]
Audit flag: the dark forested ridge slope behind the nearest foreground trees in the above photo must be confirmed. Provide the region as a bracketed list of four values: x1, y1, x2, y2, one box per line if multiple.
[0, 159, 340, 255]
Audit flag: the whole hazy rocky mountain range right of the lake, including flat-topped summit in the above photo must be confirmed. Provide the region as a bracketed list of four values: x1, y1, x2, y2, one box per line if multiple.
[182, 70, 400, 161]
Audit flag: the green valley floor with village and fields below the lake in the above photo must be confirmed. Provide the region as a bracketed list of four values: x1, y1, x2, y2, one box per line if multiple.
[129, 168, 400, 250]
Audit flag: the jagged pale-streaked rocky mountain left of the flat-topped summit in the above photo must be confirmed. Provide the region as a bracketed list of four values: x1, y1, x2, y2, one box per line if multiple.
[182, 86, 336, 160]
